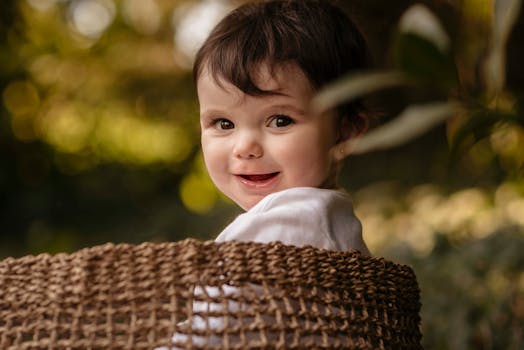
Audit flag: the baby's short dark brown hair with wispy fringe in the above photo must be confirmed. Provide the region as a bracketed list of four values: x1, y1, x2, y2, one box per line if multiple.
[193, 0, 369, 131]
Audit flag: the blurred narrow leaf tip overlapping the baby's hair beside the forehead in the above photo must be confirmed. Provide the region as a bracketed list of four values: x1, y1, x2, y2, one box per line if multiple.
[312, 71, 408, 111]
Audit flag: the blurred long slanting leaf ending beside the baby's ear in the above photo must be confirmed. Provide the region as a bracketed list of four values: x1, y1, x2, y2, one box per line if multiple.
[344, 102, 457, 154]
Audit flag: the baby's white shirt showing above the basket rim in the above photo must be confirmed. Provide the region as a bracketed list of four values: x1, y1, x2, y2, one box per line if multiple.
[216, 187, 369, 255]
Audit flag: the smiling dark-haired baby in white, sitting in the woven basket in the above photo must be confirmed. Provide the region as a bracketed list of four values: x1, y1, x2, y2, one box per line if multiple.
[162, 0, 369, 346]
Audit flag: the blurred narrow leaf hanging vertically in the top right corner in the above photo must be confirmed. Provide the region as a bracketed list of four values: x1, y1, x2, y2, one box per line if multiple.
[483, 0, 522, 96]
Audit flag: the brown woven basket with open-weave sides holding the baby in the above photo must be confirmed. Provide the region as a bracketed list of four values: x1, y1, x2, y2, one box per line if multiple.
[0, 240, 421, 350]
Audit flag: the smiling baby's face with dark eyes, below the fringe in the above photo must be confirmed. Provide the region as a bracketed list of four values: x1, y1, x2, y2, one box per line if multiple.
[197, 64, 339, 210]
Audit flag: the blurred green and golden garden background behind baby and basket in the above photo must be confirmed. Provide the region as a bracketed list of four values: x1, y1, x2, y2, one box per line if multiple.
[0, 0, 524, 349]
